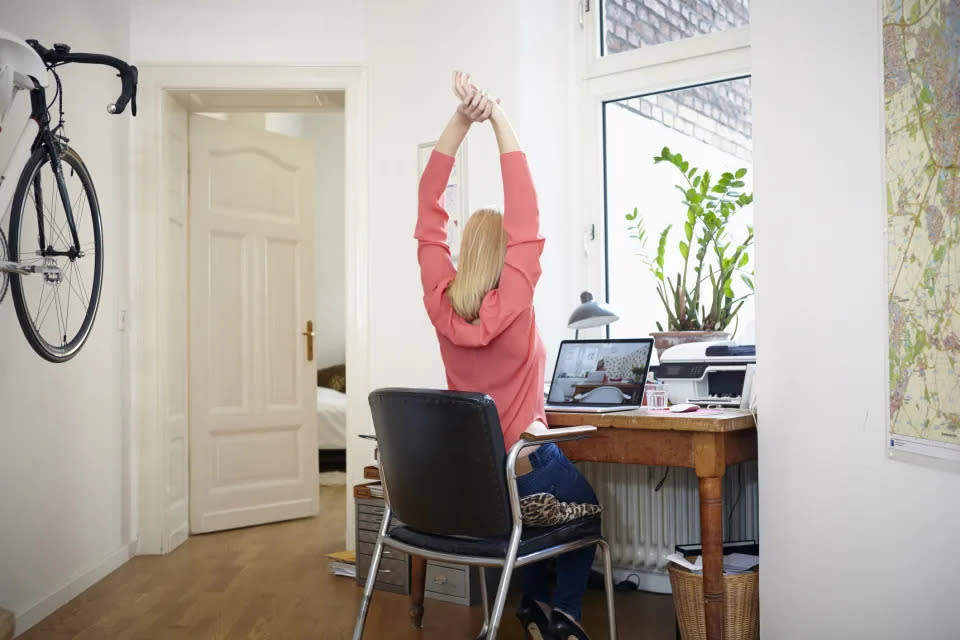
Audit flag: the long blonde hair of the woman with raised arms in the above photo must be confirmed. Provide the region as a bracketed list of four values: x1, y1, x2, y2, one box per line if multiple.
[447, 209, 507, 322]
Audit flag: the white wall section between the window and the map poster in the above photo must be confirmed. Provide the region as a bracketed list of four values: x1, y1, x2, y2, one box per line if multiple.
[751, 0, 960, 640]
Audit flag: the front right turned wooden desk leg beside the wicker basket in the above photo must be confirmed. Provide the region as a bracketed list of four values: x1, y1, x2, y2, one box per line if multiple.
[700, 477, 723, 640]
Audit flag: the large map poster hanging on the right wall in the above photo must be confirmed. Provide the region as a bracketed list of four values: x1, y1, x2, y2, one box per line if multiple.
[882, 0, 960, 461]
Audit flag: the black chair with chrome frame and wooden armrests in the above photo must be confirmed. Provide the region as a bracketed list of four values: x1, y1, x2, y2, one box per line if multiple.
[353, 389, 616, 640]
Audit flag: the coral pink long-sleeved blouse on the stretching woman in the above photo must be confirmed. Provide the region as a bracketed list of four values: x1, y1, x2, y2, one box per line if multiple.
[414, 151, 547, 449]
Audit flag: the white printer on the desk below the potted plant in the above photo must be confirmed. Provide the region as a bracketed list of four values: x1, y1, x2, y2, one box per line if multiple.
[656, 341, 757, 407]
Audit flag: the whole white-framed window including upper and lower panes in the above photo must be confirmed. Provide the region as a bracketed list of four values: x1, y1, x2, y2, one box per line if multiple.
[578, 0, 754, 350]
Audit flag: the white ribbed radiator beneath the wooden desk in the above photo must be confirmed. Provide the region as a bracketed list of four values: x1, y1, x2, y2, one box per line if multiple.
[577, 460, 760, 593]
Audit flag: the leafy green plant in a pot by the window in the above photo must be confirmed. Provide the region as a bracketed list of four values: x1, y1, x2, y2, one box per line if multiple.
[626, 147, 753, 355]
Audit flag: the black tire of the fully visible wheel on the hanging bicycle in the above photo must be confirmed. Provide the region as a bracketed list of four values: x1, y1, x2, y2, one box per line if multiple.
[8, 145, 103, 363]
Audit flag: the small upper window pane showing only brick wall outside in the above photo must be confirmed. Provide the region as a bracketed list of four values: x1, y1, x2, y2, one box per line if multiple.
[599, 0, 750, 55]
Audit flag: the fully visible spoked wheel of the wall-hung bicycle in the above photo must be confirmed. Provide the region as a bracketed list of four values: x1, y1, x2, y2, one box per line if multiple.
[8, 145, 103, 362]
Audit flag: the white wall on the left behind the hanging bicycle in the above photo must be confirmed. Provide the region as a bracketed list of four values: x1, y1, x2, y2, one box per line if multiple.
[0, 0, 135, 629]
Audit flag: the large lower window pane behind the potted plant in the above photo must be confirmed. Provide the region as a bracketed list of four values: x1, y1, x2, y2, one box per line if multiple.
[603, 78, 753, 341]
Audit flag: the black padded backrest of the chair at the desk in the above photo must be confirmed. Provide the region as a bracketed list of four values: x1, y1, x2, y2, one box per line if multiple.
[370, 389, 513, 538]
